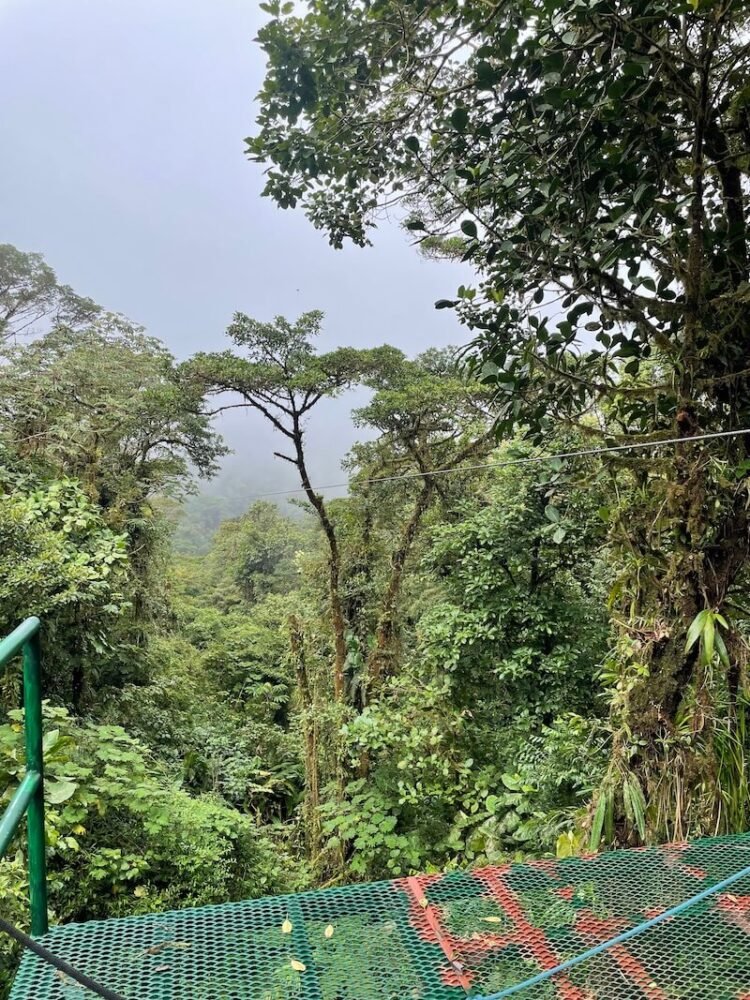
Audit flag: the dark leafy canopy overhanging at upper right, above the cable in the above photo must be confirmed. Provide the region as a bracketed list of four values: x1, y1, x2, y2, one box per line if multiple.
[248, 0, 750, 432]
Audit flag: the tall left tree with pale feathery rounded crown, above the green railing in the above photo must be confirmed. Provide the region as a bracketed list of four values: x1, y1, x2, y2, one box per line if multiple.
[0, 318, 224, 711]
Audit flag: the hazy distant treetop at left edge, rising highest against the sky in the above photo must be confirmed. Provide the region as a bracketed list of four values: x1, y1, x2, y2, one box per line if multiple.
[0, 243, 101, 342]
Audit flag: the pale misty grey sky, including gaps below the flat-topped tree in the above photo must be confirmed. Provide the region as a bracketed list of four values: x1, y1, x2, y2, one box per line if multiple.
[0, 0, 466, 500]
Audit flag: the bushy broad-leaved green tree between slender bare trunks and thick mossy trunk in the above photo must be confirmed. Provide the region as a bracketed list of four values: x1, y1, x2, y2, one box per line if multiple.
[324, 445, 608, 877]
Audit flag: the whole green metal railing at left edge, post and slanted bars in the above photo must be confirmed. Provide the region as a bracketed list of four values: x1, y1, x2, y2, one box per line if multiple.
[0, 618, 48, 937]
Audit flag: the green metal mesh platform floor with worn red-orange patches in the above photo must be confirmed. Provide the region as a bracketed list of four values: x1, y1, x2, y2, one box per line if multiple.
[11, 834, 750, 1000]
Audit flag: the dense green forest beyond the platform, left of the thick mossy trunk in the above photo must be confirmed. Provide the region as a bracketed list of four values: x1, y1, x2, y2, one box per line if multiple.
[0, 246, 608, 996]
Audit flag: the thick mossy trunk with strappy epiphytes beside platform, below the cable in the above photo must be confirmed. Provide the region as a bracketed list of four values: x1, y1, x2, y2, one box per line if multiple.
[602, 434, 750, 841]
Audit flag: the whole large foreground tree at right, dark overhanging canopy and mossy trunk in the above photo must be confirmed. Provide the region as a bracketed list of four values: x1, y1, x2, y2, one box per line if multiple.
[249, 0, 750, 836]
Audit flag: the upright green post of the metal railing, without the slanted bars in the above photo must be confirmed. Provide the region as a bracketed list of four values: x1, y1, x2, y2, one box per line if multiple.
[23, 632, 49, 937]
